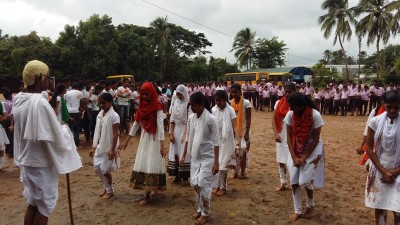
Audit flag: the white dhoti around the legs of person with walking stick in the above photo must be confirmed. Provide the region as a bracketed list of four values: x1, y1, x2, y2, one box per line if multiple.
[21, 166, 58, 217]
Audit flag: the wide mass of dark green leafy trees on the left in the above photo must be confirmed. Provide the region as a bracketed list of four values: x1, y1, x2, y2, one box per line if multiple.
[0, 14, 234, 82]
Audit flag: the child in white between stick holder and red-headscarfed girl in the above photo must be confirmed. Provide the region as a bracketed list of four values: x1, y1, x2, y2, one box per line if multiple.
[90, 93, 120, 199]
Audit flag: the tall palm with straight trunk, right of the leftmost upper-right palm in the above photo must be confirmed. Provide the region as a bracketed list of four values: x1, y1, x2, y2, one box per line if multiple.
[355, 0, 398, 80]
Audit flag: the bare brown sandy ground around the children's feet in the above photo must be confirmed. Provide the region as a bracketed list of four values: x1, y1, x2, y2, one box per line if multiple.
[0, 110, 382, 225]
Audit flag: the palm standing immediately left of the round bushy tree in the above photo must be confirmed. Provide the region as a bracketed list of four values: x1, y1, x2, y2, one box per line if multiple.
[230, 27, 256, 69]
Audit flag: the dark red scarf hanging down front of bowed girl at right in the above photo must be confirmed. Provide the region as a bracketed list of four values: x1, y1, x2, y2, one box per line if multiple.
[292, 107, 314, 157]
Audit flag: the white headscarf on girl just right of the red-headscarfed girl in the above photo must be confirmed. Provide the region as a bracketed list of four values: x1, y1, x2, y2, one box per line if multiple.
[171, 84, 189, 123]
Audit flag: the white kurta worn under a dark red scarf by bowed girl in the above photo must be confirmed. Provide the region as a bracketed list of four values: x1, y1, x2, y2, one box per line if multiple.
[285, 109, 325, 188]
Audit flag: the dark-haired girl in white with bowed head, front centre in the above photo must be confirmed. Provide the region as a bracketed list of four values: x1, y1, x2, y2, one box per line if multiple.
[181, 92, 220, 224]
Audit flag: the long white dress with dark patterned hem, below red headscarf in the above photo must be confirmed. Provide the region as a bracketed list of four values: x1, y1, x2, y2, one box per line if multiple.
[129, 110, 166, 191]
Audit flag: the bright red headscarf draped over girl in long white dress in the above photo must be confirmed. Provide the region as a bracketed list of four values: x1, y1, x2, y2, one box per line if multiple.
[135, 82, 163, 134]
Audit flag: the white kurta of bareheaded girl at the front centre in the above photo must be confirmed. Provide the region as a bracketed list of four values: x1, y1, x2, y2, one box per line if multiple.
[186, 109, 220, 188]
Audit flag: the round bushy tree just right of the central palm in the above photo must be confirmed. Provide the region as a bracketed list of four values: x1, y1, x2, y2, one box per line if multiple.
[255, 37, 287, 68]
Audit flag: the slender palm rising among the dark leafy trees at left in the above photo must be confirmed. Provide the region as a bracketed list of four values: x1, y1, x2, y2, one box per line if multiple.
[147, 16, 171, 80]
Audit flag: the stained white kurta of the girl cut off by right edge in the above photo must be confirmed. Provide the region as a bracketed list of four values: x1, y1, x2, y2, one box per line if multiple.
[365, 112, 400, 212]
